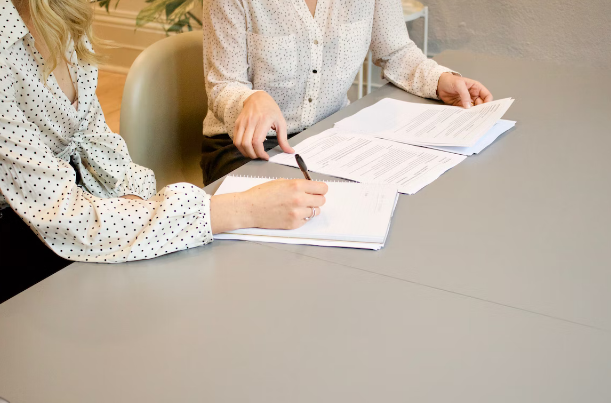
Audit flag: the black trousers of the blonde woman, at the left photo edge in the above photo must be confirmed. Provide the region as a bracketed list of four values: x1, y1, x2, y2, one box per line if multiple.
[0, 207, 72, 303]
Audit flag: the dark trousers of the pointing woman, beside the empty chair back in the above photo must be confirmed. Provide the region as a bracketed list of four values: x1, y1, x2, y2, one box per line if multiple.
[199, 133, 298, 185]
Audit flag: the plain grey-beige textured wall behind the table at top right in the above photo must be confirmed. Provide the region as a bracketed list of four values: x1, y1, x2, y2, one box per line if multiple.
[410, 0, 611, 67]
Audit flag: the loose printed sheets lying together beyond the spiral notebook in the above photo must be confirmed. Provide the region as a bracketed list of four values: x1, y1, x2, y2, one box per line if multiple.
[270, 98, 516, 194]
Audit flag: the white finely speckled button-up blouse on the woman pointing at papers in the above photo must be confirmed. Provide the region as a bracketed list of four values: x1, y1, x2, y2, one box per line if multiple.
[203, 0, 451, 137]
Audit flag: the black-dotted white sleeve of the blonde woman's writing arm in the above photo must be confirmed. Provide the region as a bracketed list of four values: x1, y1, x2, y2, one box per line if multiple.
[0, 63, 212, 262]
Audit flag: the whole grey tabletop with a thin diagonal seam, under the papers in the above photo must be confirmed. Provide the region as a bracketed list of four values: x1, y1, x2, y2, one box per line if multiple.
[0, 52, 611, 403]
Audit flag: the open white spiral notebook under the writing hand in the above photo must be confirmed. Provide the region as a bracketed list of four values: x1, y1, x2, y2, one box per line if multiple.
[215, 176, 398, 250]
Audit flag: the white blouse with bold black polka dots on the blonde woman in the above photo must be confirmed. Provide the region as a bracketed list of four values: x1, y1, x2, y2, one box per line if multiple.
[0, 0, 212, 262]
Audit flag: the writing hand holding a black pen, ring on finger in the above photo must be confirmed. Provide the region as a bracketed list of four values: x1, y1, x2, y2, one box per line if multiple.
[210, 179, 329, 234]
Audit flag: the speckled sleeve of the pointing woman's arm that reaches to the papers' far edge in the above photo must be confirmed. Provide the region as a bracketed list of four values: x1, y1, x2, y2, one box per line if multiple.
[371, 0, 460, 99]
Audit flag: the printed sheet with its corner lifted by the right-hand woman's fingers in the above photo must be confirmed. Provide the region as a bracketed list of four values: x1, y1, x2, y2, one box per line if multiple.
[335, 98, 513, 147]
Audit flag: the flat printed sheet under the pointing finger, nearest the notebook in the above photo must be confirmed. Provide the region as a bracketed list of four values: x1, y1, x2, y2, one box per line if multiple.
[270, 129, 466, 194]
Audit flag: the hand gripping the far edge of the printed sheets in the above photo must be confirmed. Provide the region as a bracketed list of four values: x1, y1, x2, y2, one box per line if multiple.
[437, 73, 492, 109]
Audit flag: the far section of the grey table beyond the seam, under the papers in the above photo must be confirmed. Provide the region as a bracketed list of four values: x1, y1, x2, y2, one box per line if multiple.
[211, 52, 611, 330]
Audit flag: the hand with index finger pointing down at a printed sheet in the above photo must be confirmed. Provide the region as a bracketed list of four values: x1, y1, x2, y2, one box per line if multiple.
[233, 91, 295, 160]
